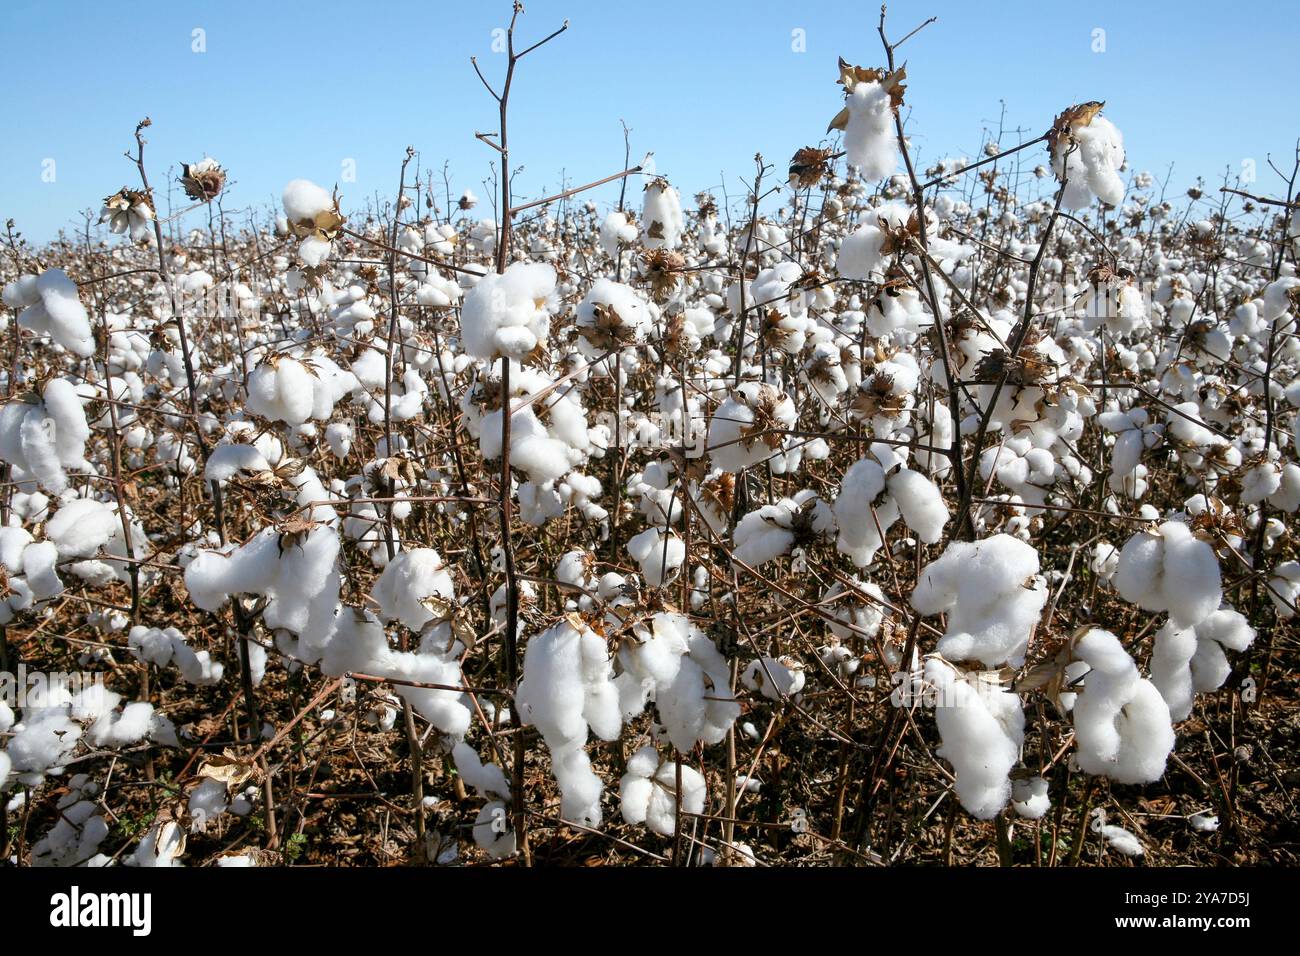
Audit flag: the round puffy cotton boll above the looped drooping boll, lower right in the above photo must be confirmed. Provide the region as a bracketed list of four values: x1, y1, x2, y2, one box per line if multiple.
[1114, 522, 1223, 627]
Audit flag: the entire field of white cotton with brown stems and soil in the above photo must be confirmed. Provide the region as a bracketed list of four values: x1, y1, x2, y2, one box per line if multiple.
[0, 4, 1300, 868]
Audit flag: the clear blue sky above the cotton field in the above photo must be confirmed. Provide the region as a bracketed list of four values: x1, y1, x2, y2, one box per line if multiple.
[0, 0, 1300, 241]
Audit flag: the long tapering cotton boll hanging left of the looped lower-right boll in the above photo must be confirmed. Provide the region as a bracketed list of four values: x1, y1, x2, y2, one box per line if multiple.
[926, 657, 1024, 819]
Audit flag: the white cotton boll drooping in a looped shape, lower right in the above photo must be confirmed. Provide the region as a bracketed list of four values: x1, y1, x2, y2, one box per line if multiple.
[1071, 628, 1174, 783]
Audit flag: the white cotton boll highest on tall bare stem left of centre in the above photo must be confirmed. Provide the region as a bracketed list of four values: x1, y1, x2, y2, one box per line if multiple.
[460, 263, 555, 362]
